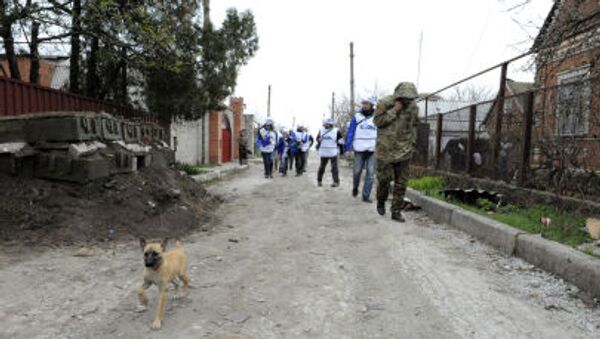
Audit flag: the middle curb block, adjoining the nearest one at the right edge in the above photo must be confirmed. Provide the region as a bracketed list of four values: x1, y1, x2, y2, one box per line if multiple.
[451, 209, 524, 255]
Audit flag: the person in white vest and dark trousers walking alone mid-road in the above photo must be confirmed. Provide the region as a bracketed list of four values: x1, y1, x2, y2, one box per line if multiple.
[317, 118, 344, 187]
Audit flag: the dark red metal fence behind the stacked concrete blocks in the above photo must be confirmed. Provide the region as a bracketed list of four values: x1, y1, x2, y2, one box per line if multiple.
[0, 77, 156, 121]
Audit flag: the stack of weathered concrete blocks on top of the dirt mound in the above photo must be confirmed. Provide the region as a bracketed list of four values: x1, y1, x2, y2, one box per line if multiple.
[0, 112, 175, 184]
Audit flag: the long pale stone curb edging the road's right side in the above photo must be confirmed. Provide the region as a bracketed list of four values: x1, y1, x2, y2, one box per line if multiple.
[406, 188, 600, 297]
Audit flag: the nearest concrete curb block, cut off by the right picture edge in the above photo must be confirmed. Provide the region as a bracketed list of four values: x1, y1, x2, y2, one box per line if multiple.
[515, 234, 600, 297]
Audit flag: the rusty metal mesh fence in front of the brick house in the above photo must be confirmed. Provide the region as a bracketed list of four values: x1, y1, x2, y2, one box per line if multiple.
[415, 60, 600, 200]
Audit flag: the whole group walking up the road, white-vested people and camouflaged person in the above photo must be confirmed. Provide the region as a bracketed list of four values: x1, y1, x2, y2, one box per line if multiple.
[257, 82, 419, 222]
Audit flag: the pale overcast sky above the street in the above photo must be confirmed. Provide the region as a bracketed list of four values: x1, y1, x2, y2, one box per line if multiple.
[211, 0, 552, 131]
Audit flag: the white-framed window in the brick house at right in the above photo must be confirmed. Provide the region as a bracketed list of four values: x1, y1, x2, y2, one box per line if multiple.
[556, 67, 592, 136]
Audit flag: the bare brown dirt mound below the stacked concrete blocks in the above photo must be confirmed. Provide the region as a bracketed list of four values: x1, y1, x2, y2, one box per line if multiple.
[0, 168, 220, 245]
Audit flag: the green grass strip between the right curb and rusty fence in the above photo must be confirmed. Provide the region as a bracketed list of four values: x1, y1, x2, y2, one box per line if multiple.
[408, 176, 597, 248]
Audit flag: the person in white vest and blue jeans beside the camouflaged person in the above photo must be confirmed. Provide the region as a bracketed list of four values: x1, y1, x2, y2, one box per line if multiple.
[346, 97, 377, 203]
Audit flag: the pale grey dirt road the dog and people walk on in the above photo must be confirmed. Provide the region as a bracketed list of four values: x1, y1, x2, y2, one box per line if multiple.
[0, 163, 600, 338]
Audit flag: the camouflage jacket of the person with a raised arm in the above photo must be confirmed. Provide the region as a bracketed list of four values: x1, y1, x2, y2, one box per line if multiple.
[374, 96, 419, 163]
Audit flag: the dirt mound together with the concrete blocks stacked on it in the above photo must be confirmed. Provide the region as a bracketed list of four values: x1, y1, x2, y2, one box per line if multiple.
[0, 112, 219, 245]
